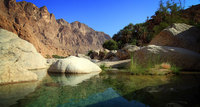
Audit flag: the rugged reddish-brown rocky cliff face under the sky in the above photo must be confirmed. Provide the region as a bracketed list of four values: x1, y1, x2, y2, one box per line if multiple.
[0, 0, 110, 57]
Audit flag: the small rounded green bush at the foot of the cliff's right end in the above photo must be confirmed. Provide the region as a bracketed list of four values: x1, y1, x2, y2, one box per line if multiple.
[103, 40, 118, 50]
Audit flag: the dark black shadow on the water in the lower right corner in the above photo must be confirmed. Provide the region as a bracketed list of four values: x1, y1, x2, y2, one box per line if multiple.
[123, 74, 200, 107]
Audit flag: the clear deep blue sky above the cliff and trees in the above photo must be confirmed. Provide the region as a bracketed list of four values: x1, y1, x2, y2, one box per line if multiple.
[16, 0, 200, 36]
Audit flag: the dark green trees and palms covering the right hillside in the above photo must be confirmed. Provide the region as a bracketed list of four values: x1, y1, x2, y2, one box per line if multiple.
[108, 0, 200, 49]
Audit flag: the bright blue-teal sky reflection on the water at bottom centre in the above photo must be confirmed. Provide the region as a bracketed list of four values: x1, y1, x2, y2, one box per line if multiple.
[58, 88, 148, 107]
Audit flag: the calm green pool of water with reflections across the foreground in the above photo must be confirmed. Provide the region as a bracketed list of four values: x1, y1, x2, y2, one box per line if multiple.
[0, 74, 200, 107]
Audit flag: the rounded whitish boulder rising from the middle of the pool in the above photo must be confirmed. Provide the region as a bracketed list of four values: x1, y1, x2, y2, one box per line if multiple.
[48, 56, 101, 73]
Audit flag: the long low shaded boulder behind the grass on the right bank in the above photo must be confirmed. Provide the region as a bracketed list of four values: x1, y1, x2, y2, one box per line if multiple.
[134, 45, 200, 70]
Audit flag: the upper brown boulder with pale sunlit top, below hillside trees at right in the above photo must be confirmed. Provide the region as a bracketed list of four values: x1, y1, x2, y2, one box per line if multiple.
[150, 23, 200, 53]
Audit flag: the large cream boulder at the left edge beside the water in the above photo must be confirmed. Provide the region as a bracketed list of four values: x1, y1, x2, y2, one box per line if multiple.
[0, 29, 47, 84]
